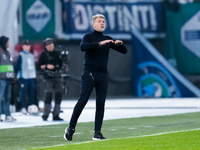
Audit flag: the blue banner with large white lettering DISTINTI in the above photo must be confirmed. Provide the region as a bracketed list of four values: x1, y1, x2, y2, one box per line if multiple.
[65, 0, 164, 39]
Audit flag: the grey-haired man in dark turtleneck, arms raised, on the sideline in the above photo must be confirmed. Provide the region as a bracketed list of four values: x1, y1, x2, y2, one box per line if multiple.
[64, 14, 127, 141]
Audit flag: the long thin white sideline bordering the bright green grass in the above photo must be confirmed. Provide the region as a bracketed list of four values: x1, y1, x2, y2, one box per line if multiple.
[33, 128, 200, 149]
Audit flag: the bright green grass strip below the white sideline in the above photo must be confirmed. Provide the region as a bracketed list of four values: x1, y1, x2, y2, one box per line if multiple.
[48, 130, 200, 150]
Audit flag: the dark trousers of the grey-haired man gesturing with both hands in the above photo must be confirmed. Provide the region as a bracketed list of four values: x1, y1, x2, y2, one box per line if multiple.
[69, 71, 108, 131]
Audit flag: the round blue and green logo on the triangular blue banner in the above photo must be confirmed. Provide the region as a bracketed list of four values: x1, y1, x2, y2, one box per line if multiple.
[137, 61, 180, 97]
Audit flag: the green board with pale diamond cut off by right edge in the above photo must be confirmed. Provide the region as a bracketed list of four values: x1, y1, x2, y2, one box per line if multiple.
[164, 3, 200, 75]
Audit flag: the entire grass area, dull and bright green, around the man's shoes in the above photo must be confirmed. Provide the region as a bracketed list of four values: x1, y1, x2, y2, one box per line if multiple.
[0, 113, 200, 150]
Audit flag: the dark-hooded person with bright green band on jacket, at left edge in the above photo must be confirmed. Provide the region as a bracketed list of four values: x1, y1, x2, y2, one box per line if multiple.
[0, 36, 16, 122]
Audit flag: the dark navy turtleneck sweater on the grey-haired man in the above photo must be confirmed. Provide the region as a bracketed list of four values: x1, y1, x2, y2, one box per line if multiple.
[80, 30, 127, 72]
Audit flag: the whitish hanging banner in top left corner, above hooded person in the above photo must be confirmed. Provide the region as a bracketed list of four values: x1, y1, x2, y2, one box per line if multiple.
[0, 0, 20, 55]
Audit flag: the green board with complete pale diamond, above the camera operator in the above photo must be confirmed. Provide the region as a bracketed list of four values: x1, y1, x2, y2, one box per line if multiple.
[22, 0, 55, 40]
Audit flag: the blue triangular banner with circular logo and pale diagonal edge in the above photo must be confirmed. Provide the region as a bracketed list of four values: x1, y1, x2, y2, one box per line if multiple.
[131, 27, 200, 98]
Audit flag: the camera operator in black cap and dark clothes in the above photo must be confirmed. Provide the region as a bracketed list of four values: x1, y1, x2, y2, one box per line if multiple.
[37, 38, 63, 121]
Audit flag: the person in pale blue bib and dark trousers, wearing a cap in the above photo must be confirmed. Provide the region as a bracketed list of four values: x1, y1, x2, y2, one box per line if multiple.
[14, 40, 36, 115]
